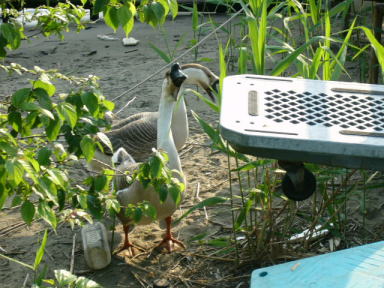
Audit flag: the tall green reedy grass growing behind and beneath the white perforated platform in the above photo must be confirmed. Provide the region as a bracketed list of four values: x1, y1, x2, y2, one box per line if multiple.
[194, 0, 384, 263]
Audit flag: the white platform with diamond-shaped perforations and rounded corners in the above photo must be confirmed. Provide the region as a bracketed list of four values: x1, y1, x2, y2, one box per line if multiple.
[220, 75, 384, 170]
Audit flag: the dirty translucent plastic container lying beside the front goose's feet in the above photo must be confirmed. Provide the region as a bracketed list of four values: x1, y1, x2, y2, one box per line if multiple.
[81, 222, 111, 270]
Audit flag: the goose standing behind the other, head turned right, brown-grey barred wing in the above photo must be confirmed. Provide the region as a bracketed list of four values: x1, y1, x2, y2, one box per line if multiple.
[89, 63, 219, 171]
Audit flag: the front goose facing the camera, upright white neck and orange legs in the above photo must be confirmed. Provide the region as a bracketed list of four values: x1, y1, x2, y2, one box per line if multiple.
[113, 64, 187, 255]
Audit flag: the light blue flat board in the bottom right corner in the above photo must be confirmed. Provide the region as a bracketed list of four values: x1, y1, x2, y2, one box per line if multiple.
[251, 241, 384, 288]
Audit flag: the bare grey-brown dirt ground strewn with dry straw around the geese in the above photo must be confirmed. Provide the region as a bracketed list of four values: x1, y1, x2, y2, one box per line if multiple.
[0, 11, 384, 288]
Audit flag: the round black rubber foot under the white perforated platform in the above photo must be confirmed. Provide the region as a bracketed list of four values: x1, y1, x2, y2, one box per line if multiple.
[282, 168, 316, 201]
